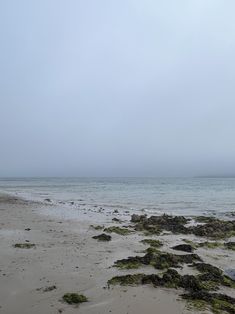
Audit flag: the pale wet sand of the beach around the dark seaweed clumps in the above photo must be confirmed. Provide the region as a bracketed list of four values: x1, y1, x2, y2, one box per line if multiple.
[0, 195, 235, 314]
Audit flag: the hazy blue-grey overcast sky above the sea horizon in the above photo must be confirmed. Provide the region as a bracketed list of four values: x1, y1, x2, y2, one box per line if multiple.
[0, 0, 235, 177]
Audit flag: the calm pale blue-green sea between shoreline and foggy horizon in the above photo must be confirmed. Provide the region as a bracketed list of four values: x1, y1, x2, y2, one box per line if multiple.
[0, 178, 235, 216]
